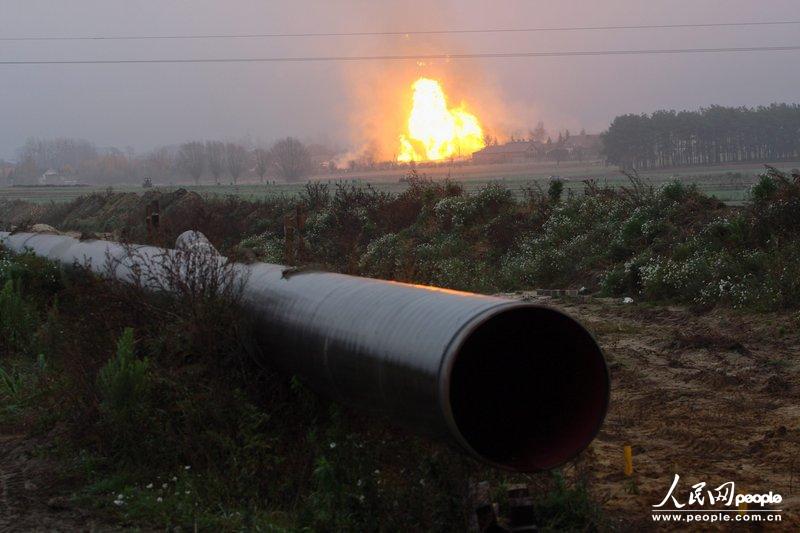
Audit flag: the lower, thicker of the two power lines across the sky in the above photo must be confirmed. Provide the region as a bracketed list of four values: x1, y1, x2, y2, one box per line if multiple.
[0, 45, 800, 65]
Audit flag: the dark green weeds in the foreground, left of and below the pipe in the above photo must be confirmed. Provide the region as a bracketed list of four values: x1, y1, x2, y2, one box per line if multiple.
[0, 244, 600, 531]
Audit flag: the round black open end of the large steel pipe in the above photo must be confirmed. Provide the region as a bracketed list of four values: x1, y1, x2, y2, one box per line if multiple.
[450, 308, 609, 471]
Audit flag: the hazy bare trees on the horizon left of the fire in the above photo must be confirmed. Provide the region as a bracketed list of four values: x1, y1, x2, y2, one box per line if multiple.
[6, 137, 314, 184]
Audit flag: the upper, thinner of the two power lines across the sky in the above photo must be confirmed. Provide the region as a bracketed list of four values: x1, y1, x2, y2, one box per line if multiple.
[0, 20, 800, 41]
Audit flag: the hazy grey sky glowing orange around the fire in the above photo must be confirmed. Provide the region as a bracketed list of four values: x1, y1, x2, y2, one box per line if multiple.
[0, 0, 800, 158]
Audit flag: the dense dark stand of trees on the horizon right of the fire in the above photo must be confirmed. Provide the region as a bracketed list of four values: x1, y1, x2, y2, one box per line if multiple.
[603, 104, 800, 169]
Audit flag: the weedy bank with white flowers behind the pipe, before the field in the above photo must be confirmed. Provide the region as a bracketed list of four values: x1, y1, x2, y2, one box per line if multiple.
[1, 168, 800, 310]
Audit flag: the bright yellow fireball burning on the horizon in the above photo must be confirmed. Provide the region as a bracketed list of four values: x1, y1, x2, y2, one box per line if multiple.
[397, 78, 486, 163]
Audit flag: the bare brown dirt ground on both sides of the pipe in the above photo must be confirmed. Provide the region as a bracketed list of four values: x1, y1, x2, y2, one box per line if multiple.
[0, 294, 800, 531]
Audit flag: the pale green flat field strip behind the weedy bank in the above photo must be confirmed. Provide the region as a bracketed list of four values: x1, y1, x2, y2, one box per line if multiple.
[0, 162, 800, 205]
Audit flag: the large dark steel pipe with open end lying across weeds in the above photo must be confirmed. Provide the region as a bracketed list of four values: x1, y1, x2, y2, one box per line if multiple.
[0, 233, 609, 471]
